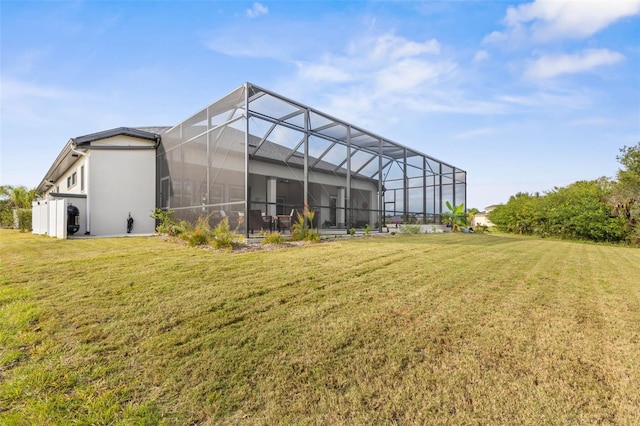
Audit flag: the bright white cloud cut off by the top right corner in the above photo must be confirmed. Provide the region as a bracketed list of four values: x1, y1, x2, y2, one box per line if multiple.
[484, 0, 640, 43]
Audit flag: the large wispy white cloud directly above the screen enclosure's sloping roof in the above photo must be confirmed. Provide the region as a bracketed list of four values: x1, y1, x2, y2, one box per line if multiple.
[287, 33, 470, 123]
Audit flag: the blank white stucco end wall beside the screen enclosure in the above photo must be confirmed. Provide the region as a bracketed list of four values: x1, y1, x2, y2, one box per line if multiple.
[89, 149, 156, 236]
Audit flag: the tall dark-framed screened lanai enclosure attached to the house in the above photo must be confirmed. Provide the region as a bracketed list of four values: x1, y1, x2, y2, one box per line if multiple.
[157, 83, 466, 234]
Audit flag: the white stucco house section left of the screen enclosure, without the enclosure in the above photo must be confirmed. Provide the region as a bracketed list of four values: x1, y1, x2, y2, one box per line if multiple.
[32, 127, 167, 238]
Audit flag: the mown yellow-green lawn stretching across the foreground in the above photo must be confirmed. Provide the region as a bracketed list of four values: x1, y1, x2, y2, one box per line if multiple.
[0, 230, 640, 425]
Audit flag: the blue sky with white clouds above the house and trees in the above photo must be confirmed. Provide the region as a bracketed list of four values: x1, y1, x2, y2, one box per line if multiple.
[0, 0, 640, 210]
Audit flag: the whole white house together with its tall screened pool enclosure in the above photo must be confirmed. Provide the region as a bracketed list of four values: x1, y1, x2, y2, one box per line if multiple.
[34, 83, 466, 237]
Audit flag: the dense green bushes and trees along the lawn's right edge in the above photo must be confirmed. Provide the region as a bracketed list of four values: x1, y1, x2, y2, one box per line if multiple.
[489, 142, 640, 246]
